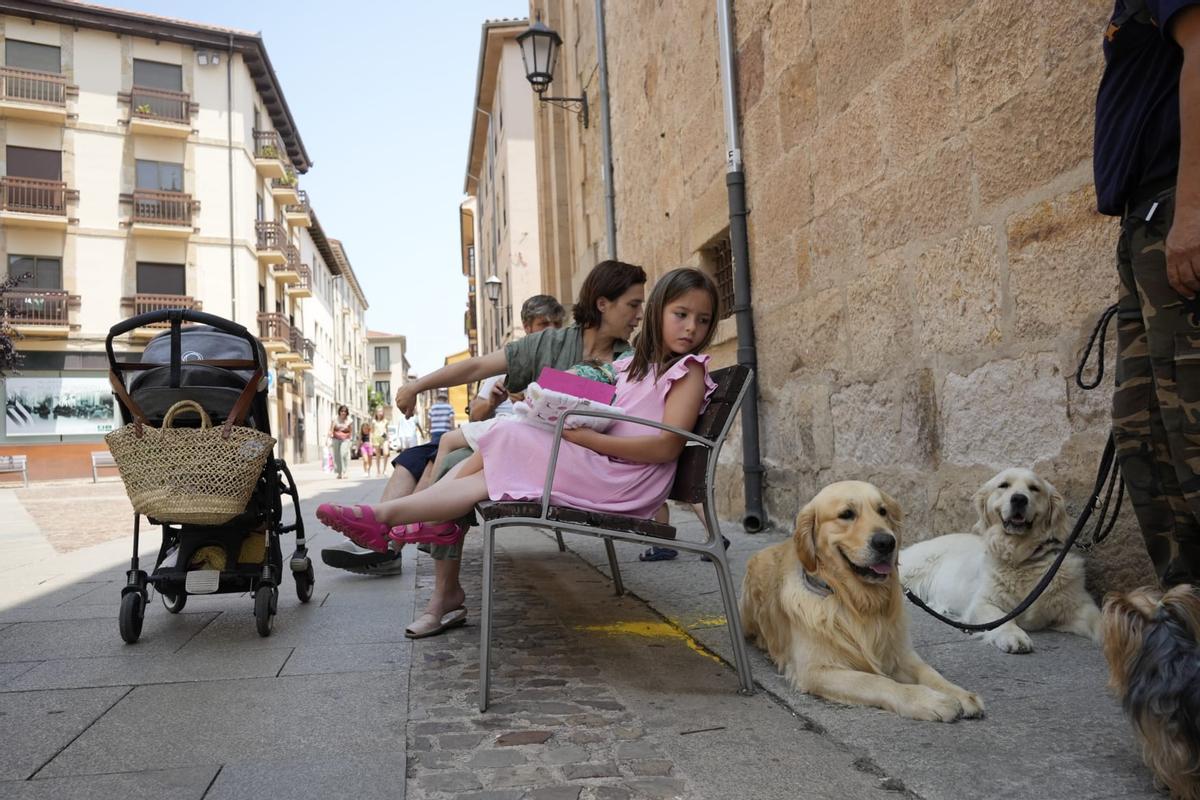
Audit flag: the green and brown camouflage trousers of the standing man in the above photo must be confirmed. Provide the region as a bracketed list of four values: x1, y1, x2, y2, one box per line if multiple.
[1112, 193, 1200, 587]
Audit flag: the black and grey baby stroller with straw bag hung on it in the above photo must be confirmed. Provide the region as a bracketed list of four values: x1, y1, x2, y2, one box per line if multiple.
[104, 308, 316, 644]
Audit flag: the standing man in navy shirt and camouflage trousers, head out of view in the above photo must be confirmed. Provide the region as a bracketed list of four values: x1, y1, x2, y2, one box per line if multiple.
[1093, 0, 1200, 587]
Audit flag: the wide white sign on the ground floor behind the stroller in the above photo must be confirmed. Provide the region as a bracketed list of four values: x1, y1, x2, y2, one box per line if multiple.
[4, 377, 118, 437]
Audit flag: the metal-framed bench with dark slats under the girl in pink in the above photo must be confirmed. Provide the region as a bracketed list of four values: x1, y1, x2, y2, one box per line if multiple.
[475, 366, 754, 711]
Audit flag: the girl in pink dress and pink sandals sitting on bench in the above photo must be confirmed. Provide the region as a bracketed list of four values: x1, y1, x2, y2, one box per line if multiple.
[317, 267, 718, 566]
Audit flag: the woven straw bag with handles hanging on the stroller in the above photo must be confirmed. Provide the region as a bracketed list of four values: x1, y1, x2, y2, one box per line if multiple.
[104, 401, 275, 525]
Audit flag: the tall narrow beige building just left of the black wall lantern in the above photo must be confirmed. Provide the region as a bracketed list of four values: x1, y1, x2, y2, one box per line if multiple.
[460, 19, 542, 353]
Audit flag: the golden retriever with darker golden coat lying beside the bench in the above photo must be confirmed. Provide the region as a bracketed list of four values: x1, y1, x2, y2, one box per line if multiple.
[742, 481, 984, 722]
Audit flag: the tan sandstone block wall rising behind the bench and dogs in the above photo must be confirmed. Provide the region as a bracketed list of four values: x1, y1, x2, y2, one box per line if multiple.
[533, 0, 1148, 588]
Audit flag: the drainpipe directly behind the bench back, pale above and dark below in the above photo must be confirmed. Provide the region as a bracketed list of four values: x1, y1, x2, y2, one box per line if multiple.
[716, 0, 766, 534]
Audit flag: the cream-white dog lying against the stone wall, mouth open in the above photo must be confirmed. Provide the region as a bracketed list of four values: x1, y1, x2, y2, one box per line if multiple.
[900, 469, 1100, 652]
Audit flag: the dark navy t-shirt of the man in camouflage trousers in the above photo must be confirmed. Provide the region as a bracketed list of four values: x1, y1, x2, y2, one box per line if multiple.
[1092, 0, 1200, 216]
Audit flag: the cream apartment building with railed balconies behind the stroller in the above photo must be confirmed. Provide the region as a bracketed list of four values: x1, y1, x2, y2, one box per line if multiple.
[0, 0, 367, 479]
